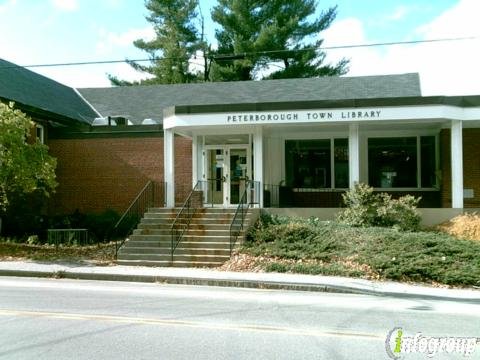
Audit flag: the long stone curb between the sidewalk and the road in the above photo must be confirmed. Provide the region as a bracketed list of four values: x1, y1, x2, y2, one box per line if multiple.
[0, 269, 480, 304]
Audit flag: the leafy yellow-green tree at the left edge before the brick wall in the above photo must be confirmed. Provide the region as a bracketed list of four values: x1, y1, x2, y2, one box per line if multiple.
[0, 103, 57, 213]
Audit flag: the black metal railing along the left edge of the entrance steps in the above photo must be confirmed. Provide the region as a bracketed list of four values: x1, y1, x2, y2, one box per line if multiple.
[110, 180, 167, 257]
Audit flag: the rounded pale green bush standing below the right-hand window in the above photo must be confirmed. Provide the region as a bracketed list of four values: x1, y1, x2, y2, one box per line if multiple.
[337, 183, 420, 231]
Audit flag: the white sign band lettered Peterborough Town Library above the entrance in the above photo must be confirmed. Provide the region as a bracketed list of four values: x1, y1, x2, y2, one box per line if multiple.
[225, 109, 382, 124]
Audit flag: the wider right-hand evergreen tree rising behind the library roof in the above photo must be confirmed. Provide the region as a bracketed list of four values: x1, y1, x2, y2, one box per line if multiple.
[212, 0, 348, 81]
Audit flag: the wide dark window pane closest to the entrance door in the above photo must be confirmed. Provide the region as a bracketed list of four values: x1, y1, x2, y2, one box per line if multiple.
[285, 139, 331, 188]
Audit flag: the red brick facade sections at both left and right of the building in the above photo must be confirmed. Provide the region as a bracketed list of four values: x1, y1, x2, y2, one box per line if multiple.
[48, 129, 480, 214]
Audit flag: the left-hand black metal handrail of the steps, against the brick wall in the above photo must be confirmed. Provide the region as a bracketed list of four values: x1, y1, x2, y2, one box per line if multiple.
[110, 180, 166, 258]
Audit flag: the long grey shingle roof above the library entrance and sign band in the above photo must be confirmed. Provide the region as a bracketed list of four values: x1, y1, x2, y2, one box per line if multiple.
[78, 73, 421, 124]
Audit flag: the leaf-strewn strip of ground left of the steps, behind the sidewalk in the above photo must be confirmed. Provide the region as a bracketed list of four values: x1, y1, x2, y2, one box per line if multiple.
[0, 240, 115, 264]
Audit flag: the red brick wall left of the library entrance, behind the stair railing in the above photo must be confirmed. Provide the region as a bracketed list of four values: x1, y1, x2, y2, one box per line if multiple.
[48, 137, 192, 214]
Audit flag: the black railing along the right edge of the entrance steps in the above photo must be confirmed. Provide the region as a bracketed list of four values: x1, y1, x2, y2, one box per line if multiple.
[230, 181, 260, 255]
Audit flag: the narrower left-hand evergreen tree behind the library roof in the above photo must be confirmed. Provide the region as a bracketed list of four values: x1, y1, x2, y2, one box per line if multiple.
[108, 0, 201, 86]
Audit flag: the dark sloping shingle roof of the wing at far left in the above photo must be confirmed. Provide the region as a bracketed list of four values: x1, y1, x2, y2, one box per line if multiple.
[0, 59, 98, 123]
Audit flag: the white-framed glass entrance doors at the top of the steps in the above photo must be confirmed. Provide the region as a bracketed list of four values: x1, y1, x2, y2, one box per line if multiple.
[203, 145, 250, 207]
